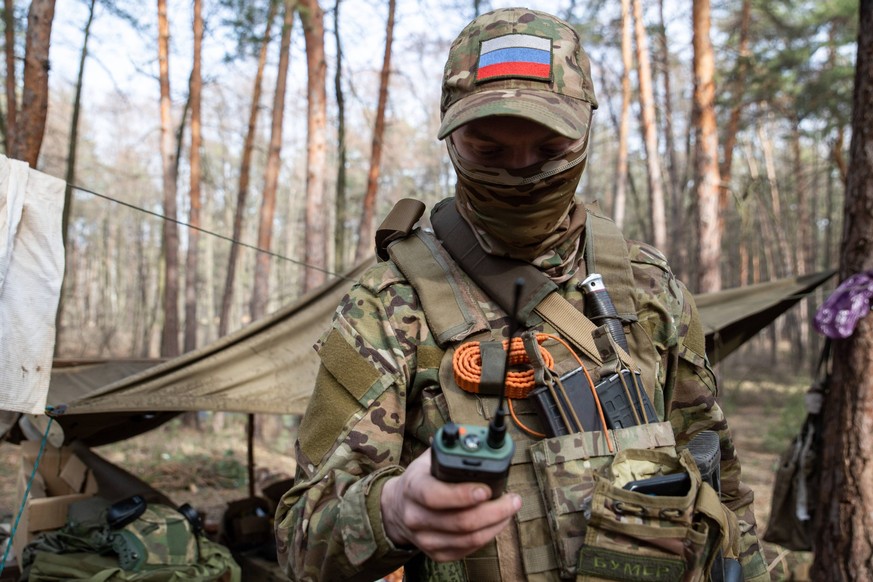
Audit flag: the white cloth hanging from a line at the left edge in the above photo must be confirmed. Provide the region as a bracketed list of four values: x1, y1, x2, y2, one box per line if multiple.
[0, 156, 65, 414]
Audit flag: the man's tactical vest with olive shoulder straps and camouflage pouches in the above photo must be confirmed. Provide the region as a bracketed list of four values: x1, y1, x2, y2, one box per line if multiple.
[377, 199, 736, 582]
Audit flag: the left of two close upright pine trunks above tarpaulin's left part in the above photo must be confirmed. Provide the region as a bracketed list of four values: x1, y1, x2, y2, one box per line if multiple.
[158, 0, 179, 357]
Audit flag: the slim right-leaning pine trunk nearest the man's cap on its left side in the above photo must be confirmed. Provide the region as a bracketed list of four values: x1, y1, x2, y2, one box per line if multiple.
[355, 0, 397, 264]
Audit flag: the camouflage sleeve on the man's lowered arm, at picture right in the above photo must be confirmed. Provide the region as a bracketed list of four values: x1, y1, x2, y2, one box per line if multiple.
[632, 245, 770, 582]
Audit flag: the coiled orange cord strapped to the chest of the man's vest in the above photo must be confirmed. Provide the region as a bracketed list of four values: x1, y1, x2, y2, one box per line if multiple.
[452, 334, 555, 398]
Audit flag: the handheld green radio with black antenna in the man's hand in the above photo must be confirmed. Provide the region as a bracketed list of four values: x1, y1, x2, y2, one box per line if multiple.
[430, 278, 524, 499]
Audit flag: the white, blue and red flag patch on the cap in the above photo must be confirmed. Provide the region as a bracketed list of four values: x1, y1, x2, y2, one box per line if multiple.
[476, 34, 552, 81]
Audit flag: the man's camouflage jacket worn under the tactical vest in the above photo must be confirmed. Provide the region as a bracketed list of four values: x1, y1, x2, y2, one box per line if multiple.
[276, 225, 769, 582]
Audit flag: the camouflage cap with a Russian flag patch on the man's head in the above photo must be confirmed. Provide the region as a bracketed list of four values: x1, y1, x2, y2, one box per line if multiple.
[438, 8, 597, 139]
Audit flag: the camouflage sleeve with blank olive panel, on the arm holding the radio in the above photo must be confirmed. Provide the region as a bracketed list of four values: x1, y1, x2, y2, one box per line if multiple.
[276, 264, 426, 581]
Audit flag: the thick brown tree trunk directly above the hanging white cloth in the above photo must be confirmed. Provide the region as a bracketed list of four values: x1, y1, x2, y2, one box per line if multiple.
[10, 0, 55, 168]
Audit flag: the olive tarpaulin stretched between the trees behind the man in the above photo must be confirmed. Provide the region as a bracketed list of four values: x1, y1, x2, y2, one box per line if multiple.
[3, 259, 833, 446]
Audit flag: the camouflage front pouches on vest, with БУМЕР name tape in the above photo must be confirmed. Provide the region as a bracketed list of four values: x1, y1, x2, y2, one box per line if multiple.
[531, 422, 729, 582]
